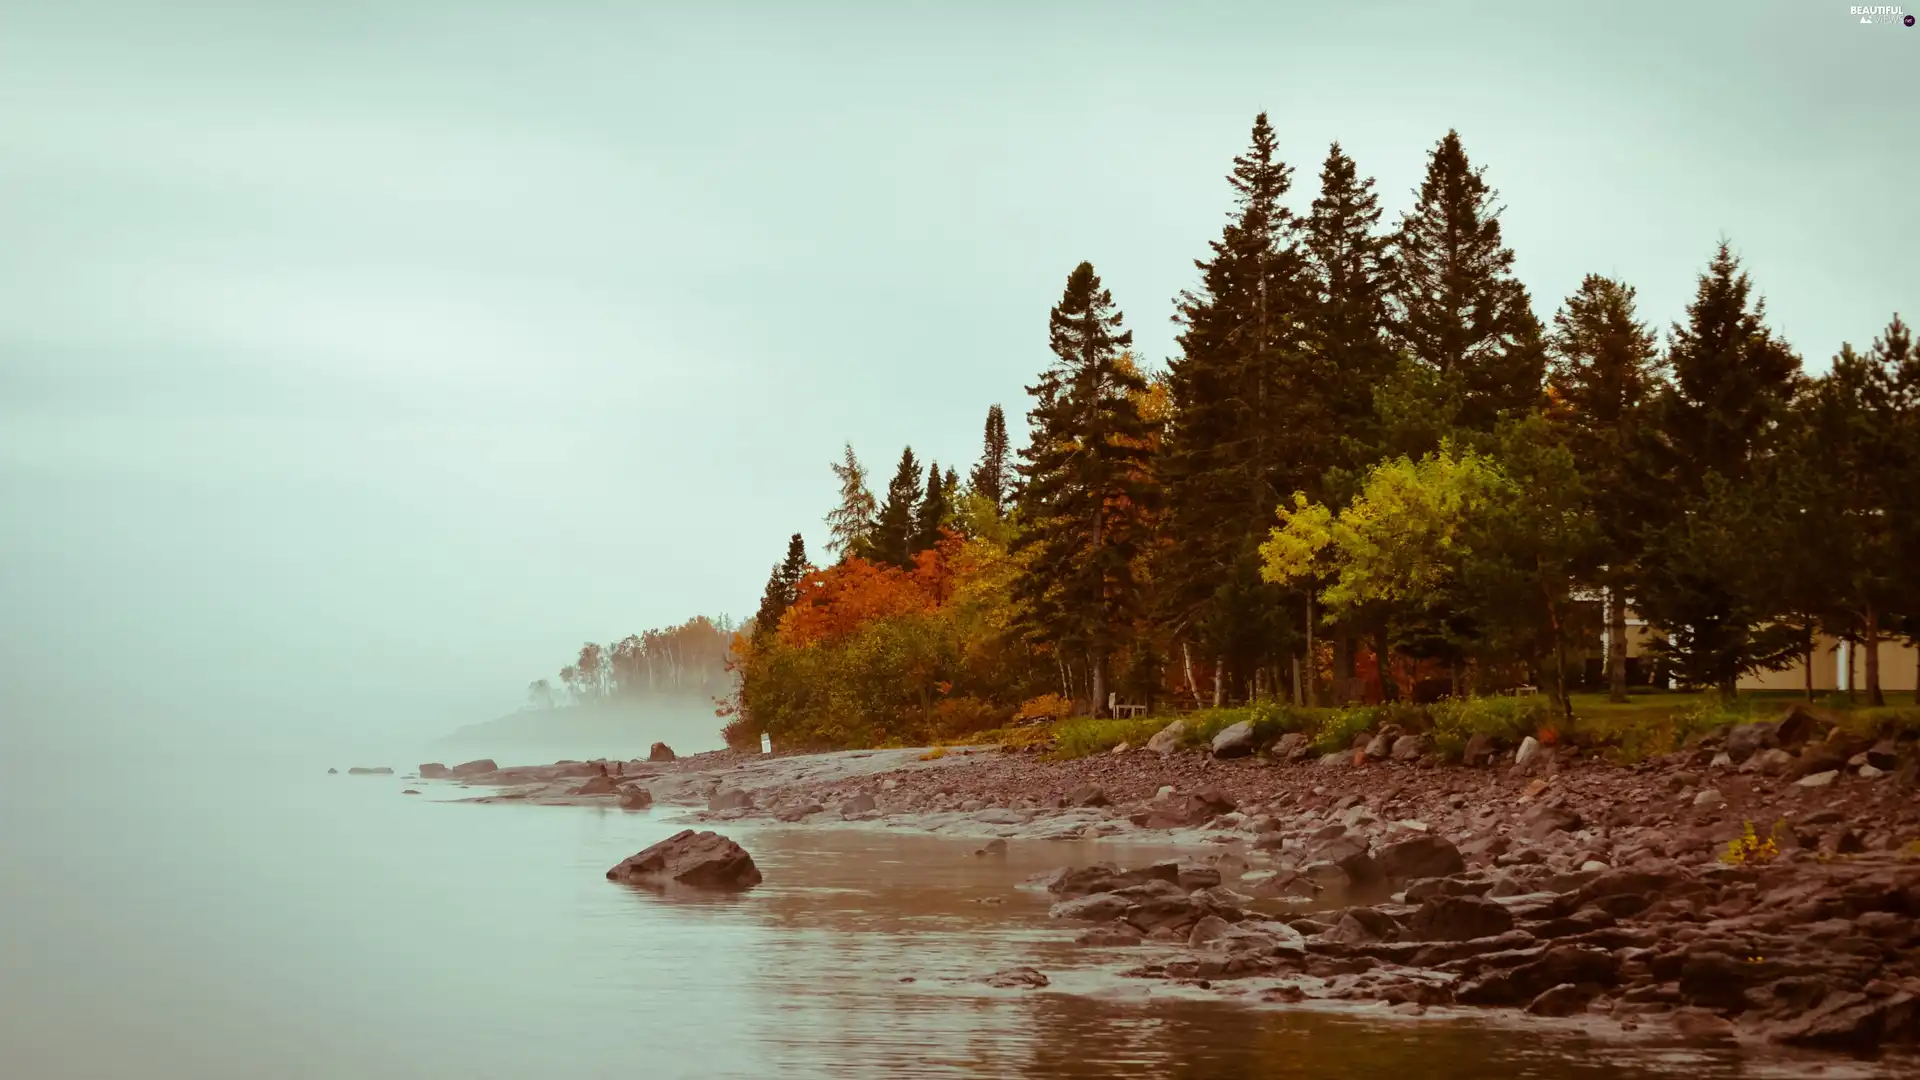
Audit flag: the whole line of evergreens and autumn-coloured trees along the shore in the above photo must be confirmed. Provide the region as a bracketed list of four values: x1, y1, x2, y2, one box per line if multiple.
[733, 115, 1920, 742]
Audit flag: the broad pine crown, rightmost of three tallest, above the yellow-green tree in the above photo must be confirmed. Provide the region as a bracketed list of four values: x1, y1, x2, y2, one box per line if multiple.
[1394, 131, 1546, 430]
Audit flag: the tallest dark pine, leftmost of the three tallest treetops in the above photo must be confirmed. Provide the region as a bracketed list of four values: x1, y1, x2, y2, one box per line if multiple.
[1156, 113, 1329, 699]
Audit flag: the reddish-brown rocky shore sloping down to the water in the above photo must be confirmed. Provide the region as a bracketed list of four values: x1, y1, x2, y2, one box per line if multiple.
[420, 711, 1920, 1053]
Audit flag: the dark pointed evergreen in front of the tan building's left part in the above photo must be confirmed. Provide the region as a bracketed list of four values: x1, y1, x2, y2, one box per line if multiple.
[1640, 242, 1799, 696]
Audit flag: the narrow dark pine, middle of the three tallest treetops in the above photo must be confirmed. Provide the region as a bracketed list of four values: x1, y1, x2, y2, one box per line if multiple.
[1302, 142, 1394, 478]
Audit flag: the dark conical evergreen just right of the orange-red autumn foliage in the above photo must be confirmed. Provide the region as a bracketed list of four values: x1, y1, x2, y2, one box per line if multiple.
[1014, 263, 1154, 715]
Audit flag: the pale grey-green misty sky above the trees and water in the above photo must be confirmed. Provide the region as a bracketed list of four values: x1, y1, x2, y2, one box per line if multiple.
[0, 0, 1920, 749]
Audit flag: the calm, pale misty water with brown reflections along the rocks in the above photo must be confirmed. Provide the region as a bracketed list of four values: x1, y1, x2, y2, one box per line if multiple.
[0, 760, 1858, 1080]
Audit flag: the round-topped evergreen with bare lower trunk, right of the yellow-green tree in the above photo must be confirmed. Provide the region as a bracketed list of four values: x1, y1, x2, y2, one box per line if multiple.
[1548, 275, 1663, 701]
